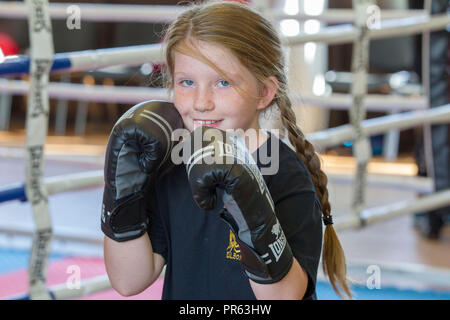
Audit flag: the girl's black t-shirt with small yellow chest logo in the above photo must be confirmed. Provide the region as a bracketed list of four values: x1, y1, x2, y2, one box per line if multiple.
[148, 134, 322, 300]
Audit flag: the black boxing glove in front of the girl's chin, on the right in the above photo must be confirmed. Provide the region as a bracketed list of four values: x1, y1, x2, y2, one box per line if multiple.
[183, 127, 293, 283]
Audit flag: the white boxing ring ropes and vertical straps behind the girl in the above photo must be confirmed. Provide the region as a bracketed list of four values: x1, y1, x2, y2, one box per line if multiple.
[0, 0, 450, 299]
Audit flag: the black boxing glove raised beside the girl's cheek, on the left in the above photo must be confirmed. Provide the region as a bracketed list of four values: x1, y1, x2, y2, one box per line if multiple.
[101, 101, 183, 242]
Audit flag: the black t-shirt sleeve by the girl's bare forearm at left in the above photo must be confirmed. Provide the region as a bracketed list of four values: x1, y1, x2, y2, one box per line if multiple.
[147, 193, 168, 262]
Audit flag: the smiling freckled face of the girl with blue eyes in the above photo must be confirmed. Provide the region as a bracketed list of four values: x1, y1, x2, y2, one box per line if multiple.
[173, 41, 273, 131]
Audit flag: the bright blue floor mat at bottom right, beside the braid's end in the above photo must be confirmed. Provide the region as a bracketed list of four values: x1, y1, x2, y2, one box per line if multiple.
[316, 281, 450, 300]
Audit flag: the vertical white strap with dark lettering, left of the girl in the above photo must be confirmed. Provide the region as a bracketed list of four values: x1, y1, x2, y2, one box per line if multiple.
[25, 0, 54, 299]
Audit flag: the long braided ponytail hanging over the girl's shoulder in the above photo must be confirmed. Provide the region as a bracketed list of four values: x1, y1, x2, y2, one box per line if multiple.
[276, 94, 352, 298]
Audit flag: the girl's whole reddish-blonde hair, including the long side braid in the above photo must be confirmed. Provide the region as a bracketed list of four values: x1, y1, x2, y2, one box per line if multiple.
[163, 1, 351, 298]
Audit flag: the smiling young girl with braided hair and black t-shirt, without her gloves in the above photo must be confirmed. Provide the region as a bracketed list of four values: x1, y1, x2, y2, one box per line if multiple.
[104, 1, 350, 299]
